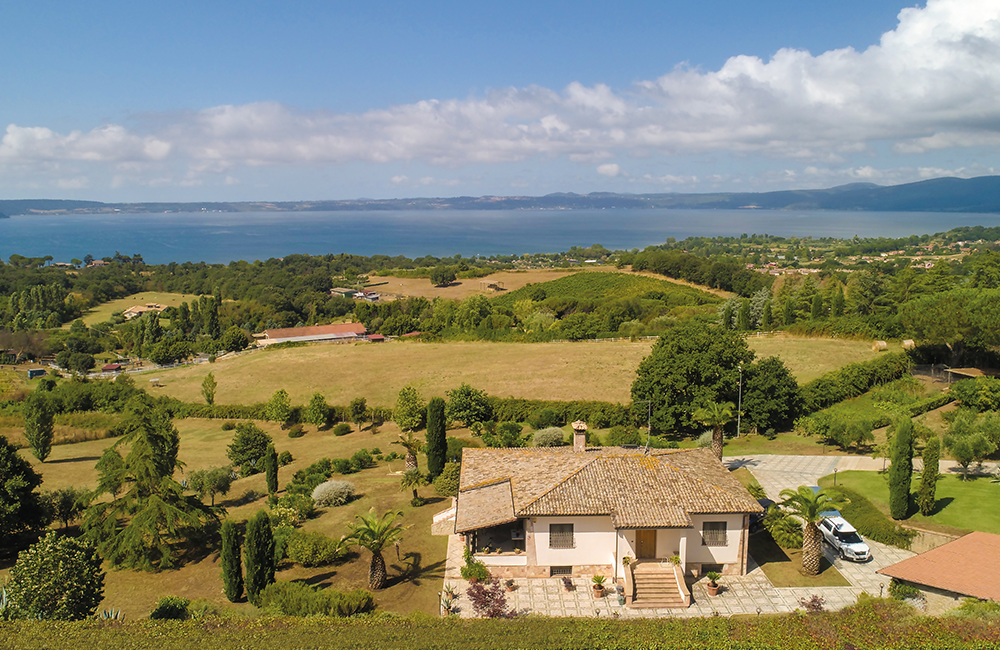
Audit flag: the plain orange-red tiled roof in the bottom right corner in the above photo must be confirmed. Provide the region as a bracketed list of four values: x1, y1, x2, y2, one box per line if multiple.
[877, 532, 1000, 601]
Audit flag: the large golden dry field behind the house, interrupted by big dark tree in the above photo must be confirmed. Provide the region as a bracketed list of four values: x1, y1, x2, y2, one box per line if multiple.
[148, 338, 874, 407]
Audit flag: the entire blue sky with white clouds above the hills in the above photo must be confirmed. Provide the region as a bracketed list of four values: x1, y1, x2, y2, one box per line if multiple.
[0, 0, 1000, 201]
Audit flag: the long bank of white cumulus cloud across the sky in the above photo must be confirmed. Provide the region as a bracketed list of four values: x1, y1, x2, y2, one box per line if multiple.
[0, 0, 1000, 192]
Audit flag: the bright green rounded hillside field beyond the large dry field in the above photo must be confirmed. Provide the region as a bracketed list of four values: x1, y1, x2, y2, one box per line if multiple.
[495, 272, 720, 307]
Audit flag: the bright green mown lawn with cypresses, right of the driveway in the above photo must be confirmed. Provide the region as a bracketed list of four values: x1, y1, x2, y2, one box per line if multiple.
[819, 472, 1000, 534]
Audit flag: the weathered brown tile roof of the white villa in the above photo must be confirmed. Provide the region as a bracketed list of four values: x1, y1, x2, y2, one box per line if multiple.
[456, 447, 762, 532]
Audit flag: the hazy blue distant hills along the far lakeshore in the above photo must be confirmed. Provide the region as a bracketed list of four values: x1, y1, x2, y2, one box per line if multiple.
[0, 176, 1000, 215]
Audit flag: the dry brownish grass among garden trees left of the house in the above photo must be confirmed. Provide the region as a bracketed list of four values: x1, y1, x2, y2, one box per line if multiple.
[0, 419, 456, 620]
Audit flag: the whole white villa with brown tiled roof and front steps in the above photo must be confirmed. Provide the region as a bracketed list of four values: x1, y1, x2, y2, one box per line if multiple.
[455, 425, 762, 607]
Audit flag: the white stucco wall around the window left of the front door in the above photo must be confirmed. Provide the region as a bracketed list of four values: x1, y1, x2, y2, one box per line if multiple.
[534, 517, 618, 566]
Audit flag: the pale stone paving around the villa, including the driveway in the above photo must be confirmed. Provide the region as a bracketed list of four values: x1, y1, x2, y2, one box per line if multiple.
[444, 455, 928, 618]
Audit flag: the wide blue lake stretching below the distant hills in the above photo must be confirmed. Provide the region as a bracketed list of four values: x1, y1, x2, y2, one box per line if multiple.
[0, 209, 1000, 264]
